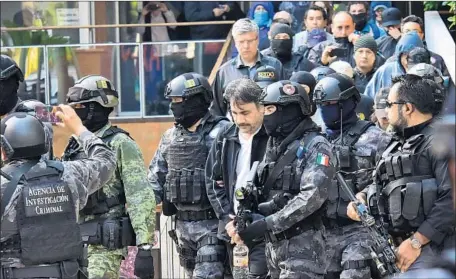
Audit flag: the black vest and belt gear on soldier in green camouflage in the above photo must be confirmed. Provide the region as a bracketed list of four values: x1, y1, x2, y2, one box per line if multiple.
[62, 126, 136, 250]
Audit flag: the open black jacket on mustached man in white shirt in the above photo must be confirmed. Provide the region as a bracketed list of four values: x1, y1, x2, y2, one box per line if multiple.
[206, 124, 269, 241]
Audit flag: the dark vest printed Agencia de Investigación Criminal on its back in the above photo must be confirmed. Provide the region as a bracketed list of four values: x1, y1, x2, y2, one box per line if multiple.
[1, 161, 82, 266]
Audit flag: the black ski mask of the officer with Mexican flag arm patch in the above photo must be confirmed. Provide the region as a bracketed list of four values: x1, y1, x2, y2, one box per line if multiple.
[263, 104, 304, 137]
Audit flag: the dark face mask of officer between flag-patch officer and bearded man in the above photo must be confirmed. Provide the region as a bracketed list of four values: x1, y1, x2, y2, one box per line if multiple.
[320, 98, 357, 130]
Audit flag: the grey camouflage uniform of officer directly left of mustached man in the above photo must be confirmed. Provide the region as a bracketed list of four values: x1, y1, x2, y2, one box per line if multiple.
[148, 113, 228, 278]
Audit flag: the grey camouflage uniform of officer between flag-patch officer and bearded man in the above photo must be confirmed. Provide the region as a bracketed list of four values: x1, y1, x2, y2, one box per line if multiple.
[325, 126, 391, 278]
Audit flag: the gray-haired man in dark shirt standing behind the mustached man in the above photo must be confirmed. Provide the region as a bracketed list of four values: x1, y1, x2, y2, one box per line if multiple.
[210, 18, 283, 116]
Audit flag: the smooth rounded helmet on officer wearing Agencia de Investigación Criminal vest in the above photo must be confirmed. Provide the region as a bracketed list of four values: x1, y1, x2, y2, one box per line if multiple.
[1, 112, 49, 160]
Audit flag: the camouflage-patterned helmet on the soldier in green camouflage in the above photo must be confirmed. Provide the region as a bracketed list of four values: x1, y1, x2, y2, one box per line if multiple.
[67, 75, 119, 108]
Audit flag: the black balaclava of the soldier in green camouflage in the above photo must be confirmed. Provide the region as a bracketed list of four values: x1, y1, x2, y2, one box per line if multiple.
[75, 102, 113, 133]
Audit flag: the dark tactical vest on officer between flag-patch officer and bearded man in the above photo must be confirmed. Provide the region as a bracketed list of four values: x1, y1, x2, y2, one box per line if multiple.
[326, 120, 374, 226]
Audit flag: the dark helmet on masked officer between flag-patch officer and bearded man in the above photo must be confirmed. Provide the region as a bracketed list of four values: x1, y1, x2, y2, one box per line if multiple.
[314, 73, 361, 104]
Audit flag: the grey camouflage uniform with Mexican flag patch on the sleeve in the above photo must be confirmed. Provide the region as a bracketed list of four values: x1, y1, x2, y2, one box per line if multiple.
[260, 119, 334, 278]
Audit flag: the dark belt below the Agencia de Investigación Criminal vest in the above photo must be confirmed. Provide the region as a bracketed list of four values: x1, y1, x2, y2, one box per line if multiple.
[0, 261, 79, 279]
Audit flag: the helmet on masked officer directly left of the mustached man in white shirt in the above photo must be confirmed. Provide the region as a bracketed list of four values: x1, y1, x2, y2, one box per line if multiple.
[165, 73, 212, 103]
